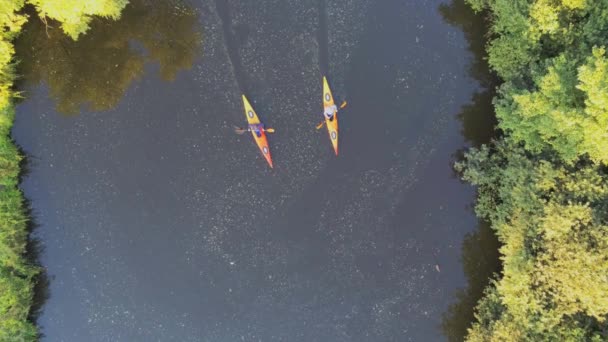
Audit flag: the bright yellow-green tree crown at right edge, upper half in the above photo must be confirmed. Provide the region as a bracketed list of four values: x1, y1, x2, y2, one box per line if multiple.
[496, 48, 608, 163]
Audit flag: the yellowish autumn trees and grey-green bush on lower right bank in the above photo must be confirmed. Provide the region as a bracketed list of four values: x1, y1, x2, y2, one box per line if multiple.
[457, 138, 608, 341]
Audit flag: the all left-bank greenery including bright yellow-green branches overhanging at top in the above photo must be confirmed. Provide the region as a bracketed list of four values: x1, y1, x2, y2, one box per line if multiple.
[0, 0, 131, 341]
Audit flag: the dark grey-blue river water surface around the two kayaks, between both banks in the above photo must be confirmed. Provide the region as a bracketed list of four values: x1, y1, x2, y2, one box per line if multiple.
[14, 0, 496, 341]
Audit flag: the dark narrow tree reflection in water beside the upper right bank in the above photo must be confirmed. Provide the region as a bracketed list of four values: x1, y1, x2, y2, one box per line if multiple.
[439, 0, 499, 146]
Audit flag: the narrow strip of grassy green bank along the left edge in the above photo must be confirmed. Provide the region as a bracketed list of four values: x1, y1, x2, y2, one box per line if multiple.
[0, 21, 39, 341]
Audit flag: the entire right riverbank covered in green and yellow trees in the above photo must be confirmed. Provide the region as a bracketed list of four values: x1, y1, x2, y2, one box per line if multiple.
[456, 0, 608, 341]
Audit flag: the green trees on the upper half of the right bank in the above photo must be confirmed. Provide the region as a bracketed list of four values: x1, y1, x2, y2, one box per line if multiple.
[470, 0, 608, 163]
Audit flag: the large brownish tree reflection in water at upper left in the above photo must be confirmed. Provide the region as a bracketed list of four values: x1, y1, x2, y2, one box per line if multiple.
[16, 0, 201, 114]
